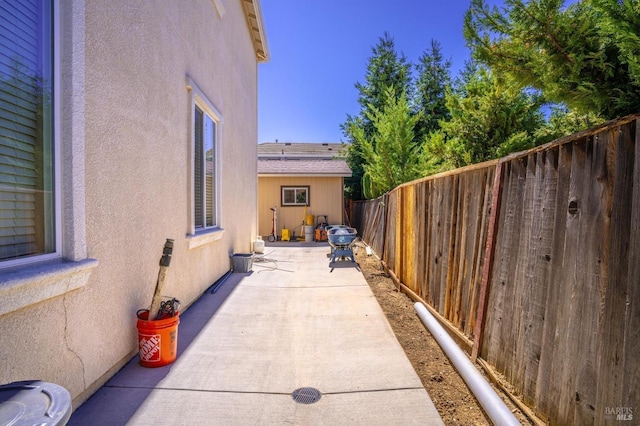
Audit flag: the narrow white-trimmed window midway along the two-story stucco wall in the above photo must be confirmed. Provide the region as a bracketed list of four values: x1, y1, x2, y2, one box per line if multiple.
[188, 80, 222, 234]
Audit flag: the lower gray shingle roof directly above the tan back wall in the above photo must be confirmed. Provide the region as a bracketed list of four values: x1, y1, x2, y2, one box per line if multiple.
[258, 160, 351, 177]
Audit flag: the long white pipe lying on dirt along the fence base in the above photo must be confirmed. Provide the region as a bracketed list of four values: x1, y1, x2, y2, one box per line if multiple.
[413, 302, 520, 425]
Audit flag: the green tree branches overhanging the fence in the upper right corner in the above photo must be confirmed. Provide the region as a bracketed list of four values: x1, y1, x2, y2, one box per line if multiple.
[464, 0, 640, 119]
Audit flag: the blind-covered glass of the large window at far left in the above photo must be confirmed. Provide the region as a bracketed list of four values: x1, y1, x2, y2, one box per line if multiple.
[0, 1, 60, 267]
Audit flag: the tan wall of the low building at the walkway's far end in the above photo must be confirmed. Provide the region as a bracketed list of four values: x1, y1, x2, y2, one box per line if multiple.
[258, 176, 343, 240]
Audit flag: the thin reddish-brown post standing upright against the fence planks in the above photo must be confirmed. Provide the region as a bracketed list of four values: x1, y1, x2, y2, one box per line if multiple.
[471, 161, 504, 362]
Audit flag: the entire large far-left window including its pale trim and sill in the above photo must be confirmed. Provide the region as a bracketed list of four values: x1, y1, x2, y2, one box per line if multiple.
[0, 0, 99, 315]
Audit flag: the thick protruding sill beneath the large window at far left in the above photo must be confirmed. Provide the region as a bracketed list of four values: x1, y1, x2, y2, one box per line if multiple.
[0, 259, 98, 315]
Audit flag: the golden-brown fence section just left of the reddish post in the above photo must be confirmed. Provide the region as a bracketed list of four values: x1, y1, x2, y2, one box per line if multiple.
[384, 162, 497, 337]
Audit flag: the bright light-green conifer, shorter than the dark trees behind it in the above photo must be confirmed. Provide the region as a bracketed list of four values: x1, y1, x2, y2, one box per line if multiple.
[351, 87, 424, 198]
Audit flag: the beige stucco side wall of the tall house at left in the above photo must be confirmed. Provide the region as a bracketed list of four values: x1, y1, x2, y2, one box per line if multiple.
[0, 0, 257, 404]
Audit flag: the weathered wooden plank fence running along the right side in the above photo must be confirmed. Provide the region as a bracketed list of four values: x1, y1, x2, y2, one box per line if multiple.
[350, 115, 640, 425]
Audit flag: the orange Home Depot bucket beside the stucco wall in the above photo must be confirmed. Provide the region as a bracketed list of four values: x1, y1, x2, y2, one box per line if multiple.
[138, 309, 180, 367]
